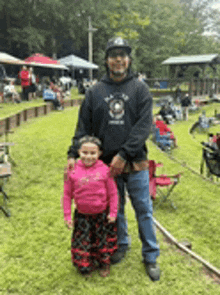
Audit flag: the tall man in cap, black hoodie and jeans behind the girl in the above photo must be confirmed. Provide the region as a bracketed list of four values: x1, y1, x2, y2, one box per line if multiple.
[68, 38, 160, 281]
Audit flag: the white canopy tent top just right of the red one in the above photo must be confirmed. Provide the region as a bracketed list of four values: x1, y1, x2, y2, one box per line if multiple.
[59, 54, 99, 70]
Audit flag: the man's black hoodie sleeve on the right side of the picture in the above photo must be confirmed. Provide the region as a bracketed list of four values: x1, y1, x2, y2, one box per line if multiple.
[119, 83, 153, 160]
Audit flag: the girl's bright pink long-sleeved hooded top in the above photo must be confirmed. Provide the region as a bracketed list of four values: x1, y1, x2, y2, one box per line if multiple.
[63, 160, 118, 220]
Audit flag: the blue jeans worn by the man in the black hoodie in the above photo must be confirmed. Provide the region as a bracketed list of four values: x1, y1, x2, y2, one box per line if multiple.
[117, 170, 159, 263]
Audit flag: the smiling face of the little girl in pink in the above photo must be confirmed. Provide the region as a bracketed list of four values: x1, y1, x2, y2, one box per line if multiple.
[78, 142, 101, 167]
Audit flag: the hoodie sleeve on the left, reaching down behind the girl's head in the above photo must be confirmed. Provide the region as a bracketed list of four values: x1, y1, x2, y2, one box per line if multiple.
[67, 95, 92, 158]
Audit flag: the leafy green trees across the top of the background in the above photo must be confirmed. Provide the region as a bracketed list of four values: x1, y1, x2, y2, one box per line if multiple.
[0, 0, 220, 77]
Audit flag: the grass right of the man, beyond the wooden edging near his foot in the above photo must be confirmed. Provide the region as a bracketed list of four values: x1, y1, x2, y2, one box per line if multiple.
[149, 104, 220, 268]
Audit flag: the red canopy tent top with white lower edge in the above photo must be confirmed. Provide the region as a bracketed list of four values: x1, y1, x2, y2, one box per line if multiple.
[25, 53, 68, 70]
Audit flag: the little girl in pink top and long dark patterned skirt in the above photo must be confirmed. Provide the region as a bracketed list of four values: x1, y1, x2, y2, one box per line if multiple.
[63, 136, 118, 277]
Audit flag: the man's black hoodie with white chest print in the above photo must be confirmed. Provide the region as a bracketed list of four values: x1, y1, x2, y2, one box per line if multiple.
[68, 74, 153, 164]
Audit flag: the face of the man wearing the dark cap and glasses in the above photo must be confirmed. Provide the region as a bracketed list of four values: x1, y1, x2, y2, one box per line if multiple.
[107, 49, 131, 79]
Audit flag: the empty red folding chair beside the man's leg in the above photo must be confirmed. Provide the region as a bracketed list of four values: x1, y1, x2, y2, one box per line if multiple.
[149, 160, 181, 209]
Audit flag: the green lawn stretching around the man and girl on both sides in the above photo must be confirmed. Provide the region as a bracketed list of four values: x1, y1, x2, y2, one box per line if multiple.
[0, 101, 220, 295]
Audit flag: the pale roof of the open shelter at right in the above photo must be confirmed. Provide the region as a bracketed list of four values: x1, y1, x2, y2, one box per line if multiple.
[162, 54, 220, 66]
